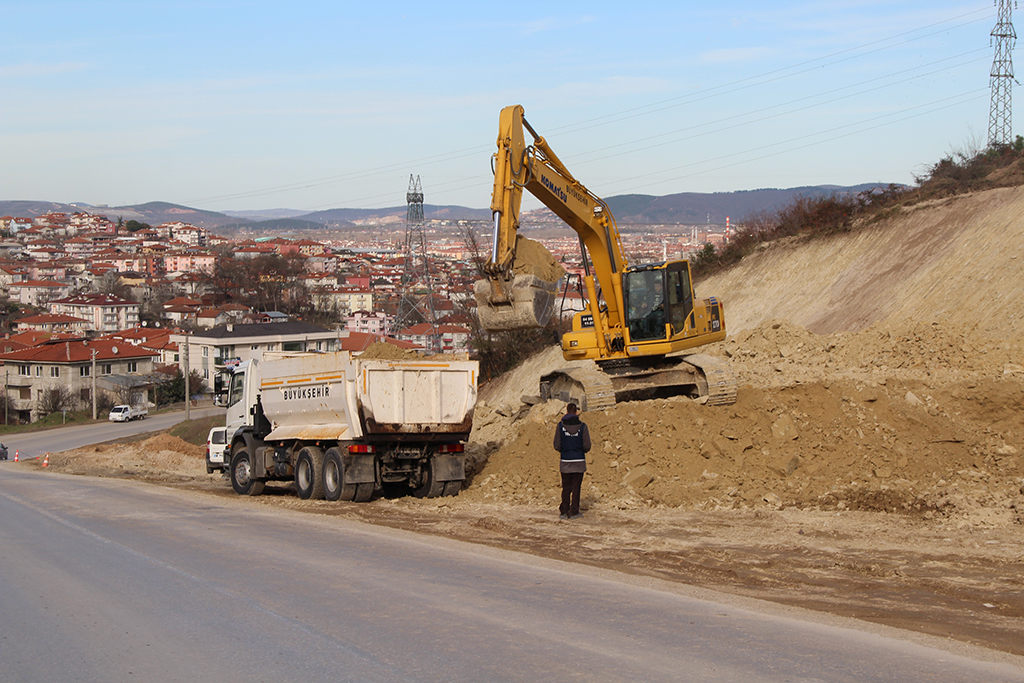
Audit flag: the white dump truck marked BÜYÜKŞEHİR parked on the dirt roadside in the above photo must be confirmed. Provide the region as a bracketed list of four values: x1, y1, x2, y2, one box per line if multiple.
[226, 351, 479, 502]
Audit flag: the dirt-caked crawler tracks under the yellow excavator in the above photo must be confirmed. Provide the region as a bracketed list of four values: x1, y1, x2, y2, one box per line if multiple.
[541, 353, 736, 411]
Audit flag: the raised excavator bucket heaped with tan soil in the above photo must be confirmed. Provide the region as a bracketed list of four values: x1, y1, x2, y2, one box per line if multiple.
[473, 274, 558, 332]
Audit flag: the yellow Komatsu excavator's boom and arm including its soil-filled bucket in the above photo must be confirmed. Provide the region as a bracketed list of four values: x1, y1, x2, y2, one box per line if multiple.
[475, 104, 627, 356]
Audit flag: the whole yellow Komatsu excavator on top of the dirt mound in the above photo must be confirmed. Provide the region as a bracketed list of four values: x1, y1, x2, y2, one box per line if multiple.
[473, 104, 736, 411]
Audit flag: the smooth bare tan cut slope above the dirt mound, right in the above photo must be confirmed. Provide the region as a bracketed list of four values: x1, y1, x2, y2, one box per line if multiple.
[696, 187, 1024, 340]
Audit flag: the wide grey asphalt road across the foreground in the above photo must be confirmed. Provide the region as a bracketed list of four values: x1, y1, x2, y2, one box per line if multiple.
[0, 471, 1024, 683]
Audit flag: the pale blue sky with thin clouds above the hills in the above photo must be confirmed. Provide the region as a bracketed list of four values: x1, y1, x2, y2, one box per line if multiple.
[0, 0, 996, 211]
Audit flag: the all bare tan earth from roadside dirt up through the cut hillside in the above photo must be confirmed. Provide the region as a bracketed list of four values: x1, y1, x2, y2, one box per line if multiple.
[26, 188, 1024, 655]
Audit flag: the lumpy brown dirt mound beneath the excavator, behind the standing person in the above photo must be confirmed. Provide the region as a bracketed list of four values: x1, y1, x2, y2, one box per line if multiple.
[464, 321, 1024, 525]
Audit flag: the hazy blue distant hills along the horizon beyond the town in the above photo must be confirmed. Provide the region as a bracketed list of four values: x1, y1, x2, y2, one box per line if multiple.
[0, 182, 888, 230]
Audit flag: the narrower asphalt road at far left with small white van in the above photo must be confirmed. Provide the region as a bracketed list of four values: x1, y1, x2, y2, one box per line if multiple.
[0, 408, 224, 462]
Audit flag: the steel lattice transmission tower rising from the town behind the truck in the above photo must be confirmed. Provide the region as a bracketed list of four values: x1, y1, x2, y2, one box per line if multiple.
[392, 174, 437, 350]
